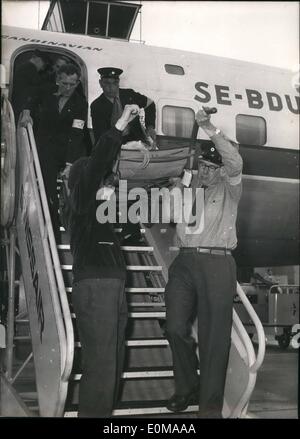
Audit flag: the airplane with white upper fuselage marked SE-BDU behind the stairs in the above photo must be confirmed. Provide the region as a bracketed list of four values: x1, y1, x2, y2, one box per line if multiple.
[1, 2, 299, 420]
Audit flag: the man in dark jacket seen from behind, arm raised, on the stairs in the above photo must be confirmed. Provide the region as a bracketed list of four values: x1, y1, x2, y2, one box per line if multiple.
[69, 105, 138, 418]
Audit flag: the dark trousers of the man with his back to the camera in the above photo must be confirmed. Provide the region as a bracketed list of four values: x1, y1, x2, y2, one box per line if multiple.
[72, 279, 127, 418]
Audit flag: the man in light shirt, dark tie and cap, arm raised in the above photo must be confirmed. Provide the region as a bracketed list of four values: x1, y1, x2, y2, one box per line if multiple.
[165, 110, 243, 418]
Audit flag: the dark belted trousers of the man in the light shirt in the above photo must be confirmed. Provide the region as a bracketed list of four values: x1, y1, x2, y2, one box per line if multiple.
[165, 252, 236, 418]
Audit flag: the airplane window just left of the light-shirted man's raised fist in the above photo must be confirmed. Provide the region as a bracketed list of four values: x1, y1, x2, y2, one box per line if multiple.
[162, 105, 195, 138]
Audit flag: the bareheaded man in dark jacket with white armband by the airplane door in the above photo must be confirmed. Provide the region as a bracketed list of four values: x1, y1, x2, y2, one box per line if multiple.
[20, 64, 87, 237]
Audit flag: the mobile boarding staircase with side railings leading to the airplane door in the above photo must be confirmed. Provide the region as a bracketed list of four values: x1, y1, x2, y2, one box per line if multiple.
[0, 100, 265, 418]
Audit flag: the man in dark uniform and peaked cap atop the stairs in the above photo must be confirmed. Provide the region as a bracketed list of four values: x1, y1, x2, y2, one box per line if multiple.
[91, 67, 156, 144]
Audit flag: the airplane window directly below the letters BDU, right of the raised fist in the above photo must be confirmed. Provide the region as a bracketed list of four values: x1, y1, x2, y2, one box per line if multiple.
[236, 114, 267, 146]
